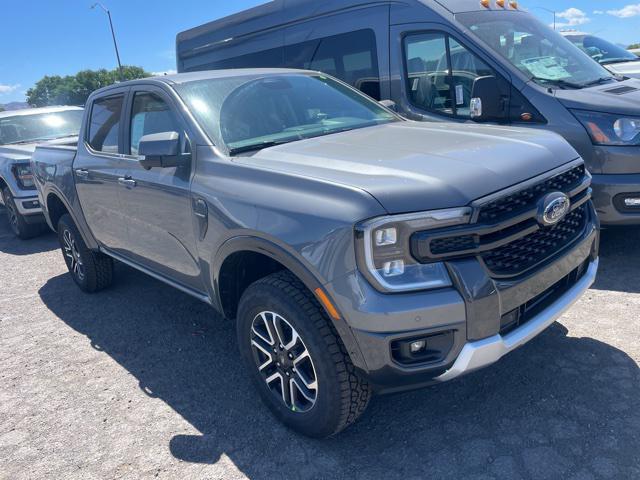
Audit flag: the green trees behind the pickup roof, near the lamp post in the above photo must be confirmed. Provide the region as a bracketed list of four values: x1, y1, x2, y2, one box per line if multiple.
[27, 65, 151, 107]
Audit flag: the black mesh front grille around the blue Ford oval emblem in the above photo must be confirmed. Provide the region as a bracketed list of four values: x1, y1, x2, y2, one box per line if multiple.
[411, 164, 591, 278]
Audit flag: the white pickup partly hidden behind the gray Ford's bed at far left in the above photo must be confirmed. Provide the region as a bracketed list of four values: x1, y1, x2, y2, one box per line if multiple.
[0, 107, 82, 239]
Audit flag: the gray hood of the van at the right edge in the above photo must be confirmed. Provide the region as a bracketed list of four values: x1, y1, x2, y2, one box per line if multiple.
[555, 78, 640, 116]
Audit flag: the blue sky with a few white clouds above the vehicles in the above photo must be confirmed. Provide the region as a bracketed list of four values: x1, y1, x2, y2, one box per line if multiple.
[0, 0, 640, 103]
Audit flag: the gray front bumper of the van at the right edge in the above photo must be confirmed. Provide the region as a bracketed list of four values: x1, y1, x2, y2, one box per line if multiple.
[592, 174, 640, 226]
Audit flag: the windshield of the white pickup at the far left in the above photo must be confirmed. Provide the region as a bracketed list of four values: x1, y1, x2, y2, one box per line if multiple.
[0, 110, 82, 145]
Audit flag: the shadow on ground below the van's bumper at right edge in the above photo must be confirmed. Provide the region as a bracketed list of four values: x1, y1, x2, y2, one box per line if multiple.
[593, 227, 640, 293]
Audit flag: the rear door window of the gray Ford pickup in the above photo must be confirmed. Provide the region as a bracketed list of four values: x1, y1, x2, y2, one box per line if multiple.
[89, 95, 124, 153]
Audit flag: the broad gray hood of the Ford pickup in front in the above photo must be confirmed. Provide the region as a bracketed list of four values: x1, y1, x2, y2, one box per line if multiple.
[234, 121, 578, 213]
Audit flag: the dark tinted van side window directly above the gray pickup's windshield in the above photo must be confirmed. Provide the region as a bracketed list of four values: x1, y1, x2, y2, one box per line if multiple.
[285, 29, 380, 100]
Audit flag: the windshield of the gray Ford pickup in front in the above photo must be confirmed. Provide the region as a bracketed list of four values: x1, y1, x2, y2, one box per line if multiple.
[175, 74, 398, 155]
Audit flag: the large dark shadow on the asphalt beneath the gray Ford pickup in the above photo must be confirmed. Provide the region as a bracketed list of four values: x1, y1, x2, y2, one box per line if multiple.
[40, 265, 640, 479]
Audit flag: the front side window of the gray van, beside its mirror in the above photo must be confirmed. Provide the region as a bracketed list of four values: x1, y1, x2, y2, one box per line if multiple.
[405, 32, 495, 118]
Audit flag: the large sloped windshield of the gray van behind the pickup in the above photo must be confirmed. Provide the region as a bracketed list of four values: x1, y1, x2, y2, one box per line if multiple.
[456, 11, 615, 88]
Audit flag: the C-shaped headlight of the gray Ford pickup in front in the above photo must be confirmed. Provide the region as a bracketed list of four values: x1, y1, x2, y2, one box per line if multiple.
[356, 208, 471, 293]
